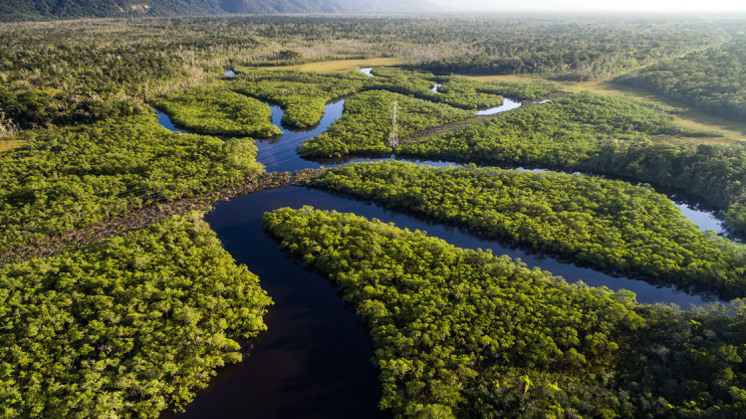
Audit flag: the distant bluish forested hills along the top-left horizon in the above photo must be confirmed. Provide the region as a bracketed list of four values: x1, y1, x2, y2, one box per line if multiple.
[0, 0, 429, 22]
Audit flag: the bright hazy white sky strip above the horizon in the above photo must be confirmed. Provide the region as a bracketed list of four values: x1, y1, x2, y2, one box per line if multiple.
[429, 0, 746, 12]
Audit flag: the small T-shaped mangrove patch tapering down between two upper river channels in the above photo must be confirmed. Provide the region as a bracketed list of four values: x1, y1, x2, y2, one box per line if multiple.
[231, 71, 366, 128]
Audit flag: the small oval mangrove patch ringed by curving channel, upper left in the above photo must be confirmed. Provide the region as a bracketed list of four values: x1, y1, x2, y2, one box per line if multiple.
[155, 87, 282, 138]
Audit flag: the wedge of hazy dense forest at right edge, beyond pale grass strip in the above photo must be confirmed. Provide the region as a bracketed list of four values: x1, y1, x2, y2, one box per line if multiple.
[619, 36, 746, 121]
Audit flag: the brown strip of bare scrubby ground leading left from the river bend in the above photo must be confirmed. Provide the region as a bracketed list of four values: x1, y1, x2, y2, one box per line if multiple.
[0, 172, 291, 263]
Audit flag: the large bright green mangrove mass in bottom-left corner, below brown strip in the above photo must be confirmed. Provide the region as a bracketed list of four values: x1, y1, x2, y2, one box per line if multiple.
[0, 213, 271, 417]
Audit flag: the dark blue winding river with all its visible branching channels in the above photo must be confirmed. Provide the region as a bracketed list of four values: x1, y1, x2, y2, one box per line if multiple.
[159, 74, 722, 418]
